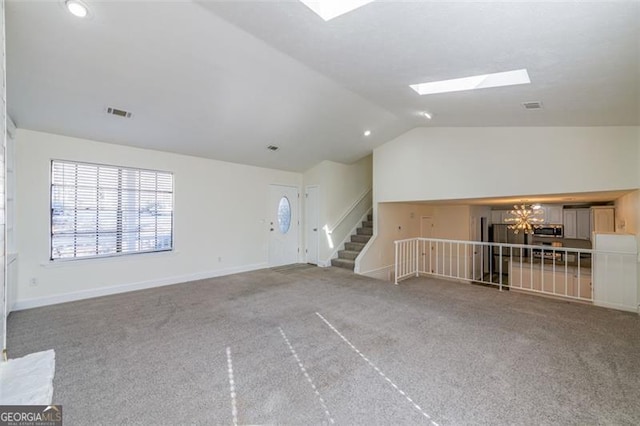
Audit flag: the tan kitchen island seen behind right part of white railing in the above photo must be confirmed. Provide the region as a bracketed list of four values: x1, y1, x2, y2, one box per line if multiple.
[509, 258, 592, 301]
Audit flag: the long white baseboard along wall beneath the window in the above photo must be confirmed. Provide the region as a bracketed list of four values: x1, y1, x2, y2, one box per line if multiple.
[12, 262, 269, 311]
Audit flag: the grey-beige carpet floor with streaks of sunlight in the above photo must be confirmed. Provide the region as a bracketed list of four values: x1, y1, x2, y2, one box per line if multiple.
[8, 268, 640, 425]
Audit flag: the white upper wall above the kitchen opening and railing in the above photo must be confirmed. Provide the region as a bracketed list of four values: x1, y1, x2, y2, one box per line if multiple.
[373, 127, 640, 202]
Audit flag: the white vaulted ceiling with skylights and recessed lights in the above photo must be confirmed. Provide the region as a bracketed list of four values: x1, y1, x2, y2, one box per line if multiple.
[6, 0, 640, 171]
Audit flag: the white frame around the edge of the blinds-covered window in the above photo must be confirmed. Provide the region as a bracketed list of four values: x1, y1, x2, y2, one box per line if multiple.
[48, 158, 175, 264]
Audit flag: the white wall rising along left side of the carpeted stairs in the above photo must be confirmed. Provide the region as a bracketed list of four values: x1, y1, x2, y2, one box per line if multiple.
[303, 155, 373, 266]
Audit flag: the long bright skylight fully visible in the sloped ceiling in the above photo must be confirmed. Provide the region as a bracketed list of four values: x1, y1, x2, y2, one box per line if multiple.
[409, 69, 531, 95]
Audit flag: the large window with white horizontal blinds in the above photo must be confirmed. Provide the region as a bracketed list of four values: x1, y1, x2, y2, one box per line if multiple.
[51, 160, 173, 260]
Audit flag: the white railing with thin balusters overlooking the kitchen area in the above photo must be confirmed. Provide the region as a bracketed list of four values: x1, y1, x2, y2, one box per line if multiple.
[395, 238, 595, 301]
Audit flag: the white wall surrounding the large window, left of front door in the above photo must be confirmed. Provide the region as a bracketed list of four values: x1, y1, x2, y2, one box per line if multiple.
[16, 129, 302, 308]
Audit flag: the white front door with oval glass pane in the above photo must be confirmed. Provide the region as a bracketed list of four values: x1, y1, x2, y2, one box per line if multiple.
[268, 185, 299, 266]
